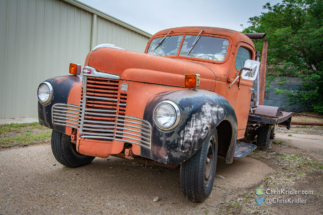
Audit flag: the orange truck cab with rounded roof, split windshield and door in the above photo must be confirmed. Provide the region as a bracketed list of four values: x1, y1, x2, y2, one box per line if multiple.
[145, 27, 255, 139]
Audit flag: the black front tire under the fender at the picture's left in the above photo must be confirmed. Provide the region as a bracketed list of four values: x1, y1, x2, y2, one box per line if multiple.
[51, 130, 94, 168]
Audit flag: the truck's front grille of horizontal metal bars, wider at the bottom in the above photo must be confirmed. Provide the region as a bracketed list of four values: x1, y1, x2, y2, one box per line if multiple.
[52, 75, 152, 149]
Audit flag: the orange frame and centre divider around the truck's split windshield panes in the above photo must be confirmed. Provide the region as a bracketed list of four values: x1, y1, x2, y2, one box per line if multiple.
[145, 32, 232, 64]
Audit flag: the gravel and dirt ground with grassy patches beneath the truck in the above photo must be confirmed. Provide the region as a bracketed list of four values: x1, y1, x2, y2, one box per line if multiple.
[0, 127, 323, 214]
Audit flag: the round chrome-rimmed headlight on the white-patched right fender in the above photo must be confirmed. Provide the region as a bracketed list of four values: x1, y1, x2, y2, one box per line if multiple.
[154, 101, 181, 130]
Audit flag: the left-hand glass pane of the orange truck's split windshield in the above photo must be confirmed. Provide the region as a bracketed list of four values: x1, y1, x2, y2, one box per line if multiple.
[147, 35, 183, 56]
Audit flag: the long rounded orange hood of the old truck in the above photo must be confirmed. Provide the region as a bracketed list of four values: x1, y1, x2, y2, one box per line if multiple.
[85, 48, 215, 90]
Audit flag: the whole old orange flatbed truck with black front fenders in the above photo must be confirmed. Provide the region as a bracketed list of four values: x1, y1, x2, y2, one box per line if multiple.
[38, 27, 291, 202]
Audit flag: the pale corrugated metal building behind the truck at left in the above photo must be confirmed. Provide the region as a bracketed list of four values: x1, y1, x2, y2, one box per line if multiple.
[0, 0, 152, 119]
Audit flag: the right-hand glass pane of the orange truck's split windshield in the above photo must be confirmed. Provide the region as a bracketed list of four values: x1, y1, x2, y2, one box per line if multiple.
[179, 35, 229, 61]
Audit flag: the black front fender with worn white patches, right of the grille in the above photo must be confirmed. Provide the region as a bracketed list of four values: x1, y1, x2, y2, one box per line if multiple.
[141, 89, 238, 164]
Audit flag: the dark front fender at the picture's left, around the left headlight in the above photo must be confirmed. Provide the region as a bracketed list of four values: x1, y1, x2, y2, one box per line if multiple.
[38, 75, 82, 133]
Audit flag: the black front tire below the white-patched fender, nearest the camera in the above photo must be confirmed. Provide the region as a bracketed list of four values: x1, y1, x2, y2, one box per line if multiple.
[180, 130, 218, 202]
